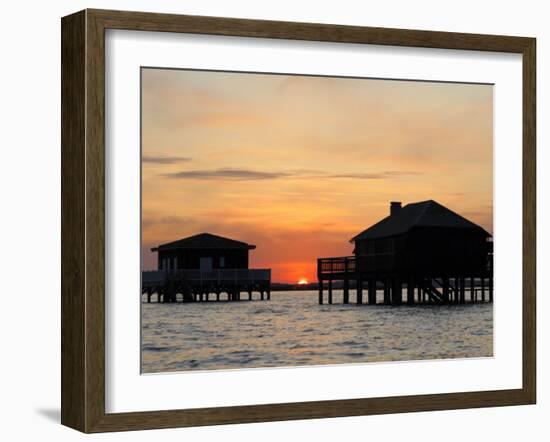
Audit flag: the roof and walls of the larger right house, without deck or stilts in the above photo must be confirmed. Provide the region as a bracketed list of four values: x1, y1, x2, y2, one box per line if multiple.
[351, 200, 492, 276]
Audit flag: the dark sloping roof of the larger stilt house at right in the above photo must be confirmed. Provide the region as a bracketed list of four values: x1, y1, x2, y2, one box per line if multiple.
[351, 200, 491, 242]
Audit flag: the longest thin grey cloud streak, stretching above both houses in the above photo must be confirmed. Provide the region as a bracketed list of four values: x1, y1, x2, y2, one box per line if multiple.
[161, 168, 421, 181]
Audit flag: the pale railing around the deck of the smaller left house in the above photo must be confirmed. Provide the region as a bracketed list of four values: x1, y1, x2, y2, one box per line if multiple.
[141, 269, 271, 284]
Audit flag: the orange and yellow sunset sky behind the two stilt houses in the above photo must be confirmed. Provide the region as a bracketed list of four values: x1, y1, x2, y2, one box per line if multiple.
[142, 69, 493, 282]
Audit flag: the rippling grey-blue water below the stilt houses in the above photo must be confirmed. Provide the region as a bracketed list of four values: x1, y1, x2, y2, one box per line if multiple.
[142, 291, 493, 373]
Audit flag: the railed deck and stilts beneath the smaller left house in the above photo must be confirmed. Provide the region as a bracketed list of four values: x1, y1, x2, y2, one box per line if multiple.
[141, 269, 271, 303]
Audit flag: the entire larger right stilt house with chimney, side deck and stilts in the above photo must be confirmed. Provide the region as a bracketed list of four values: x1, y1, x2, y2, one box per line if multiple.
[317, 200, 493, 304]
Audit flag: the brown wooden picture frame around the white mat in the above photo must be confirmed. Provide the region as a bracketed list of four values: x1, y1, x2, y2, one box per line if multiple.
[61, 10, 536, 432]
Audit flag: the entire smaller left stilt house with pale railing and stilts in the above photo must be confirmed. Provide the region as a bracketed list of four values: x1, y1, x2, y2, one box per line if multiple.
[141, 233, 271, 302]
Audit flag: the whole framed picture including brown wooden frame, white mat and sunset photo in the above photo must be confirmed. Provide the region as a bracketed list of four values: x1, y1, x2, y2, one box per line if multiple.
[62, 10, 536, 432]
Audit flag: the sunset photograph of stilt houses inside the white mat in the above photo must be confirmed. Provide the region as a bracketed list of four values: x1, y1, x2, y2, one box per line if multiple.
[140, 67, 495, 374]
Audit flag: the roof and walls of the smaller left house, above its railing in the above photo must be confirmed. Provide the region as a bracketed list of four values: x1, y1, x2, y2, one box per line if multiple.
[151, 233, 256, 271]
